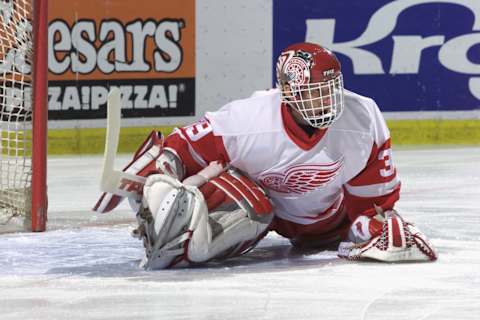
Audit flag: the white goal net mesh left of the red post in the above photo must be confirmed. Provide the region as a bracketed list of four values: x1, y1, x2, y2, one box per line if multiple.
[0, 0, 33, 227]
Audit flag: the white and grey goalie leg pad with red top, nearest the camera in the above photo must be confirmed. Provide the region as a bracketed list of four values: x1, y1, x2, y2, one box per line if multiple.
[134, 169, 273, 269]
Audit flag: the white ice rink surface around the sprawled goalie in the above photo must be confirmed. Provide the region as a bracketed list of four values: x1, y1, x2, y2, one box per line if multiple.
[0, 147, 480, 320]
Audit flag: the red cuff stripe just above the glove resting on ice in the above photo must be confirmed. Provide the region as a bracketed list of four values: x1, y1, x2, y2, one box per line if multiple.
[343, 183, 400, 221]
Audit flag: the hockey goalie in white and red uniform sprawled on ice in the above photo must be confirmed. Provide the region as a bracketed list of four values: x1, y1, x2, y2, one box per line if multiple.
[95, 43, 437, 269]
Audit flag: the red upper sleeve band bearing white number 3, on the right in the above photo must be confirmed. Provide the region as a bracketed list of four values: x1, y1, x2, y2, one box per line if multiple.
[348, 139, 397, 187]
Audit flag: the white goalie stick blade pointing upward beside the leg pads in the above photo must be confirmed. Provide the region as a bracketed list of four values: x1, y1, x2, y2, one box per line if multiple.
[100, 88, 146, 200]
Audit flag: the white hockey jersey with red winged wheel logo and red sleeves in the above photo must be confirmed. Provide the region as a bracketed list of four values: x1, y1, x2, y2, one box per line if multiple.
[167, 89, 399, 230]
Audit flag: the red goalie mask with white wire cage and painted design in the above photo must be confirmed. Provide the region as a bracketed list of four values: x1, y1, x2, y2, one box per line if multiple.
[276, 43, 344, 128]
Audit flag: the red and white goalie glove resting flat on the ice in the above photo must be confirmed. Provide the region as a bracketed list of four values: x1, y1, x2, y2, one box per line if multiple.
[338, 210, 437, 262]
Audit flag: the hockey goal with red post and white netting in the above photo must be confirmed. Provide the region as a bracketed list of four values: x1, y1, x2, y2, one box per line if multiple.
[0, 0, 47, 231]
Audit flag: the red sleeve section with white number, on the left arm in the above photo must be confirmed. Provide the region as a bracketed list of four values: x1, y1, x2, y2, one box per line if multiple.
[164, 118, 230, 177]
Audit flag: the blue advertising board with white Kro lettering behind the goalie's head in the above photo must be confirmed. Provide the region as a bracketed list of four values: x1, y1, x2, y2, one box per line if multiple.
[273, 0, 480, 111]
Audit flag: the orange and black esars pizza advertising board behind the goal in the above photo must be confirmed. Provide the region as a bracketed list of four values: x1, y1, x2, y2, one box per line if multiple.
[48, 0, 195, 119]
